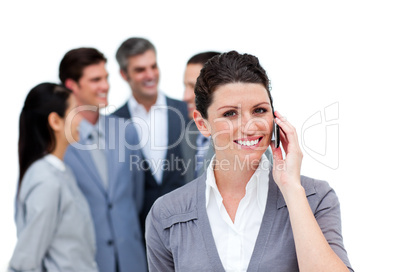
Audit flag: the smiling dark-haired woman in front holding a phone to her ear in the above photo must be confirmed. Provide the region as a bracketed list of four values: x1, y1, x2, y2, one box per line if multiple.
[146, 51, 353, 272]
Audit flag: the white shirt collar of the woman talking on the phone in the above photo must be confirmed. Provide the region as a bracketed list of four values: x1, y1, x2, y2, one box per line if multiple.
[205, 154, 271, 213]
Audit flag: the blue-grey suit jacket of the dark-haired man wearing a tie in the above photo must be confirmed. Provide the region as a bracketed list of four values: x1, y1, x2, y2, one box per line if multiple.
[64, 115, 147, 272]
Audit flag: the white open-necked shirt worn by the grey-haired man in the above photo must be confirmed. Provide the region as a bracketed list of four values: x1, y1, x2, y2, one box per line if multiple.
[128, 92, 168, 184]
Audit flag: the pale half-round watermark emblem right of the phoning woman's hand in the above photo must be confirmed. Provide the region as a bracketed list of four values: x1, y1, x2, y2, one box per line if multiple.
[300, 102, 339, 170]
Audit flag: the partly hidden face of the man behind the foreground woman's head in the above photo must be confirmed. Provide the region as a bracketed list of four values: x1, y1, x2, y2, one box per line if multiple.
[183, 63, 202, 120]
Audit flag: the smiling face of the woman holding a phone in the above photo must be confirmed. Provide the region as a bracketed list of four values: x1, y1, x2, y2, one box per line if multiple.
[207, 83, 273, 163]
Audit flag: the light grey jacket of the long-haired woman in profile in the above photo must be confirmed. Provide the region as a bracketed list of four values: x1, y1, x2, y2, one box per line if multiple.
[9, 158, 98, 272]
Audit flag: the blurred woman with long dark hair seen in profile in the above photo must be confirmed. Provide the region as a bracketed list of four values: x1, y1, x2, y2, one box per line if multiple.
[9, 83, 98, 272]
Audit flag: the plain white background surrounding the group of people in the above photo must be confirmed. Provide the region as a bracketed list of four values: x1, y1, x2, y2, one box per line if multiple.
[0, 0, 402, 271]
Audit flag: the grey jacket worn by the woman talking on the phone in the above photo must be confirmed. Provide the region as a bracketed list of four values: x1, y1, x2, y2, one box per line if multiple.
[145, 171, 353, 272]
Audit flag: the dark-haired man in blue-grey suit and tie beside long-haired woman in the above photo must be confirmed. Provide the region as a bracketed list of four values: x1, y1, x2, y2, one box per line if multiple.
[59, 48, 147, 272]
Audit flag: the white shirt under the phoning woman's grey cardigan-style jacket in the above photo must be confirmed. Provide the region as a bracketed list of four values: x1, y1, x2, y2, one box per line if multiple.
[205, 154, 270, 272]
